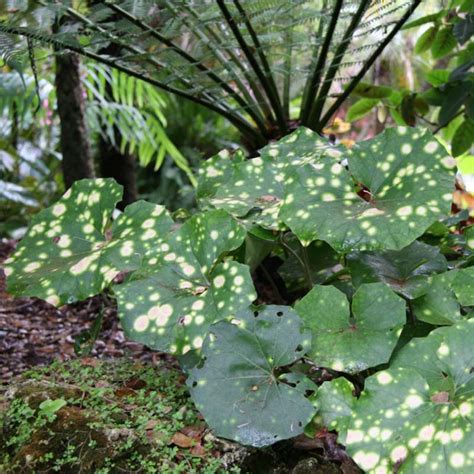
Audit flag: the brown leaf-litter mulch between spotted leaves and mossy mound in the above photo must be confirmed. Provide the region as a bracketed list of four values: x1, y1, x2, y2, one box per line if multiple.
[0, 240, 163, 385]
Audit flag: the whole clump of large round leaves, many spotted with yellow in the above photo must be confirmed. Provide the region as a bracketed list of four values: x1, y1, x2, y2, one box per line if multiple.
[5, 127, 474, 473]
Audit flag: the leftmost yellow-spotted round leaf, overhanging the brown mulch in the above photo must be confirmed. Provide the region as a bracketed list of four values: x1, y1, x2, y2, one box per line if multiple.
[5, 179, 173, 305]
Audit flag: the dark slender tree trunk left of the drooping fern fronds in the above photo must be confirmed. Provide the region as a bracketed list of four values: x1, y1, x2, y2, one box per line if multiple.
[56, 53, 94, 188]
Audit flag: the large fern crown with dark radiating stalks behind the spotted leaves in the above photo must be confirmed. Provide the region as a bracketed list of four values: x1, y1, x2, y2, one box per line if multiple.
[0, 0, 421, 145]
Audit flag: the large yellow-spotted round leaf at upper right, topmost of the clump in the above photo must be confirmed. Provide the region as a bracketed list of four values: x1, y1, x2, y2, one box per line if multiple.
[280, 127, 454, 252]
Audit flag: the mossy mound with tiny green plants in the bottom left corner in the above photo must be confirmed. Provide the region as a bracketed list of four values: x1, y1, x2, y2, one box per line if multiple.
[0, 358, 239, 474]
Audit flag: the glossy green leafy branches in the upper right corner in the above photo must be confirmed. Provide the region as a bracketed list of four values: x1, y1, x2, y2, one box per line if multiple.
[346, 1, 474, 158]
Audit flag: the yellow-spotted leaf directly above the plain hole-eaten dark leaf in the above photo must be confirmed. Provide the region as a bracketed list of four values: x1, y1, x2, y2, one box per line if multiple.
[115, 211, 256, 354]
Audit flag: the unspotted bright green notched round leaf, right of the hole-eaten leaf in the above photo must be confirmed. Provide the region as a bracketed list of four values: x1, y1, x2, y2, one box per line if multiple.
[295, 283, 406, 373]
